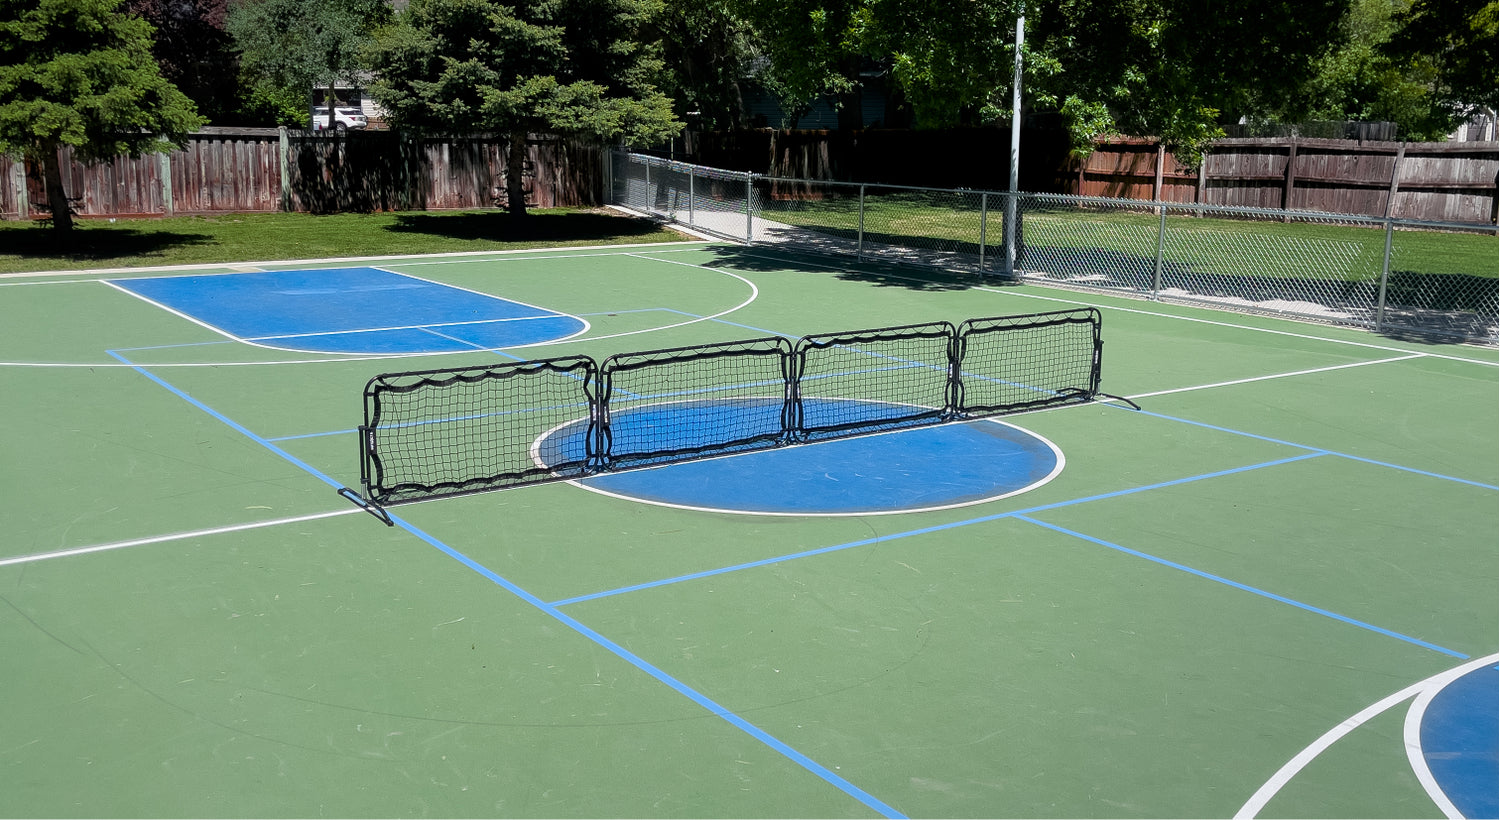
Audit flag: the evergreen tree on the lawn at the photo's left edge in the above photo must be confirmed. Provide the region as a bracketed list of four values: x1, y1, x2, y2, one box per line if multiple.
[0, 0, 204, 237]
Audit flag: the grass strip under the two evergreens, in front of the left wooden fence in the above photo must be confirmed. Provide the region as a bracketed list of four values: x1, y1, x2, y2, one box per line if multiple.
[0, 208, 684, 273]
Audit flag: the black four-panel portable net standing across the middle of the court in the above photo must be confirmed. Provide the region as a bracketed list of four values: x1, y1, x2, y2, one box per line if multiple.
[351, 307, 1103, 509]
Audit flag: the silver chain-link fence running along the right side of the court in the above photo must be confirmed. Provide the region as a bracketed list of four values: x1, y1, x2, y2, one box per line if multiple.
[608, 151, 1500, 346]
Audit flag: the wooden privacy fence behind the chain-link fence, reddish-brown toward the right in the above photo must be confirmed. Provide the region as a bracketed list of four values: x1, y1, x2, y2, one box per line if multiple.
[681, 127, 1500, 225]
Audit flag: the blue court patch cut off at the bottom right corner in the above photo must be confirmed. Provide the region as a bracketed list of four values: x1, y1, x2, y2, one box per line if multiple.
[1422, 664, 1500, 817]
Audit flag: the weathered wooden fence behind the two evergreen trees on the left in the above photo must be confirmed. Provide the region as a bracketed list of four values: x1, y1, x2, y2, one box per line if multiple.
[0, 129, 603, 219]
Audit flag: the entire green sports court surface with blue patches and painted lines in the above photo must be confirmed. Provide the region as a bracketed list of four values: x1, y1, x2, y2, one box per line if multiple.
[0, 243, 1500, 817]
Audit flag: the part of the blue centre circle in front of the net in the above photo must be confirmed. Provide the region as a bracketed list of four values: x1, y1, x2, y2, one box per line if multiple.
[578, 421, 1064, 516]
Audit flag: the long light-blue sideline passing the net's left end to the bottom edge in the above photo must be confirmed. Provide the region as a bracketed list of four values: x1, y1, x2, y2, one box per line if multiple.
[107, 351, 906, 819]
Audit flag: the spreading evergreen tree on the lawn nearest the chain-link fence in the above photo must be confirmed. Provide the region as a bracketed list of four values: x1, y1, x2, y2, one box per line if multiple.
[366, 0, 683, 217]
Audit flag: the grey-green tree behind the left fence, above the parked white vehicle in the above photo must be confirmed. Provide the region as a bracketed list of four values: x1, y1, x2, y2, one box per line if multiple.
[225, 0, 392, 129]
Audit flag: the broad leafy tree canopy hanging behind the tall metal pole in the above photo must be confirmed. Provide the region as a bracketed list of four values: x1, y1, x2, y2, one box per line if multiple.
[741, 0, 1350, 160]
